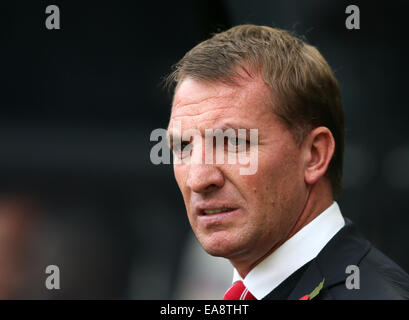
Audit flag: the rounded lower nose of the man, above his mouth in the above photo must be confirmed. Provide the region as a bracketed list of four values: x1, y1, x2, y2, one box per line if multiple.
[187, 164, 224, 193]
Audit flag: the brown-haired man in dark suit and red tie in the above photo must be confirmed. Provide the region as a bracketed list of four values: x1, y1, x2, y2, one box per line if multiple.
[168, 25, 409, 300]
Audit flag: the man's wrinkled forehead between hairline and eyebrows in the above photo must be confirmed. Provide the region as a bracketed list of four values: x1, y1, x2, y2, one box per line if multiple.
[170, 78, 273, 127]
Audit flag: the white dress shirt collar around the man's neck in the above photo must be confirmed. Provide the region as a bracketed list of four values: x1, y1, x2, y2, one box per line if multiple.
[233, 201, 345, 300]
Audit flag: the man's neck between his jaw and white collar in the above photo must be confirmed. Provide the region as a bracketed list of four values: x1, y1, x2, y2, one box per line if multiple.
[230, 179, 334, 279]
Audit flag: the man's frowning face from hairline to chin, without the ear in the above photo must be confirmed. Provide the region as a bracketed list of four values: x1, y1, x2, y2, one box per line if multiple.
[168, 78, 306, 268]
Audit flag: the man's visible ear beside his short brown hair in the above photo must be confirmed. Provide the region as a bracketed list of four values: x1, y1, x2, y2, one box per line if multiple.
[302, 127, 335, 184]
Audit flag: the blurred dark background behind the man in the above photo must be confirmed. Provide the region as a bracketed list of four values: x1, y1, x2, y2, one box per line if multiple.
[0, 0, 409, 299]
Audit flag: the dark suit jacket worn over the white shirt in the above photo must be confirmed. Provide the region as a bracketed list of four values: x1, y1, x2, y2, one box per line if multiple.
[263, 219, 409, 300]
